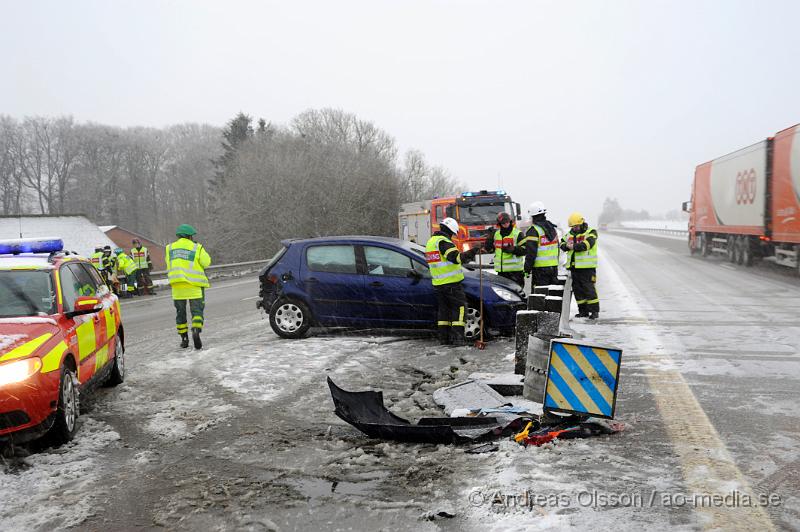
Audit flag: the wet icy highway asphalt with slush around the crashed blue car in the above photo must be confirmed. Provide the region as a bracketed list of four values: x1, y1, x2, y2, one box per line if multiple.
[0, 234, 800, 530]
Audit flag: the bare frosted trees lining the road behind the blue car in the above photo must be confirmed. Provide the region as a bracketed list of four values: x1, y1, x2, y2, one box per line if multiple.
[0, 109, 462, 263]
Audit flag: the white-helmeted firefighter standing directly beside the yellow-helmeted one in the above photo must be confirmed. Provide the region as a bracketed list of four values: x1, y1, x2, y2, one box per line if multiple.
[523, 201, 558, 292]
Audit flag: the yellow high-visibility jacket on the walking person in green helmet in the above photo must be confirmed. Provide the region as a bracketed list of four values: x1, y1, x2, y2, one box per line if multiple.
[164, 238, 211, 299]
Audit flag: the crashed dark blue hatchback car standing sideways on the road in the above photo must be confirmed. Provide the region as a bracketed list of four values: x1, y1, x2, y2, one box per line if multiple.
[257, 236, 525, 338]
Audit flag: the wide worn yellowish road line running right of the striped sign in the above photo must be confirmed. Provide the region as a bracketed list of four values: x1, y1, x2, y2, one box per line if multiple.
[605, 251, 775, 531]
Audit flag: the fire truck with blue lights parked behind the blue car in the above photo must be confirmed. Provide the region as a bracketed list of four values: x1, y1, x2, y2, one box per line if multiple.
[397, 190, 524, 255]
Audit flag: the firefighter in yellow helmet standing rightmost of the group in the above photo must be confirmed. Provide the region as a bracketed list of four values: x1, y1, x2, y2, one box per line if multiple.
[561, 212, 600, 320]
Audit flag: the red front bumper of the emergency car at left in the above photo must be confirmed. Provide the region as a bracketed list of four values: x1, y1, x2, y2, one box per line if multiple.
[0, 371, 60, 442]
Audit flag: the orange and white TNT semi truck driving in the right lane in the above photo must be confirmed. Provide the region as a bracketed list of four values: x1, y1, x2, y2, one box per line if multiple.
[683, 124, 800, 273]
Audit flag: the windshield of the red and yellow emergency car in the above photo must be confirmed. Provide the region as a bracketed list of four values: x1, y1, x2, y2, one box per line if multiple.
[0, 270, 55, 318]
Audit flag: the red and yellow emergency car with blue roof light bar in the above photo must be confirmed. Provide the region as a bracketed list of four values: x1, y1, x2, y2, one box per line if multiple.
[0, 238, 125, 444]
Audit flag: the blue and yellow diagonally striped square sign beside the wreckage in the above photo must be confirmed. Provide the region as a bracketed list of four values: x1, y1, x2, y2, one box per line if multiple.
[544, 340, 622, 419]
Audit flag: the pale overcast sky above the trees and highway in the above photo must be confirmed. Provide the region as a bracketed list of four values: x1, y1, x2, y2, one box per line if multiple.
[0, 0, 800, 223]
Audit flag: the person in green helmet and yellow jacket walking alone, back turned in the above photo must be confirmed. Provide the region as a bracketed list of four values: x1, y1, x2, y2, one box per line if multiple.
[165, 224, 211, 349]
